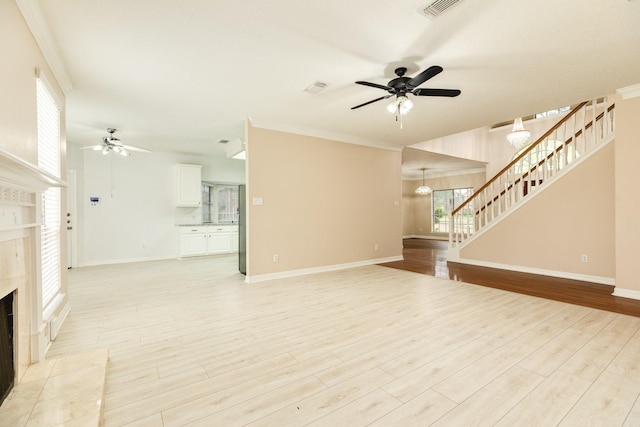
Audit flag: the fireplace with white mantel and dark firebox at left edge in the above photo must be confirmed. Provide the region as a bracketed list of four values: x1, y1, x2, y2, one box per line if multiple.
[0, 147, 69, 397]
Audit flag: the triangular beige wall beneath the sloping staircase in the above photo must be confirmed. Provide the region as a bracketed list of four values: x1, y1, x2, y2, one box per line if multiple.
[460, 143, 616, 279]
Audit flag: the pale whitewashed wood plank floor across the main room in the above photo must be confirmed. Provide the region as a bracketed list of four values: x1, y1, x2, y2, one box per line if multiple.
[49, 256, 640, 427]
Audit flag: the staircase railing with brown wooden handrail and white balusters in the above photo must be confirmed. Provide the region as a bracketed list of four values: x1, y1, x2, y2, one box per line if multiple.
[449, 98, 615, 260]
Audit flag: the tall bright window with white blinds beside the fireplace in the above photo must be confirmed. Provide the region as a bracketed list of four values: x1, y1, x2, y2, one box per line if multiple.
[36, 78, 62, 308]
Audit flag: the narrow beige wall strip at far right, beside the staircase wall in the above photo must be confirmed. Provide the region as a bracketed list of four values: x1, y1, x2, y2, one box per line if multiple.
[614, 96, 640, 298]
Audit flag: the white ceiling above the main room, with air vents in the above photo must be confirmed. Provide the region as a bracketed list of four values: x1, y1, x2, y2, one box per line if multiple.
[39, 0, 640, 171]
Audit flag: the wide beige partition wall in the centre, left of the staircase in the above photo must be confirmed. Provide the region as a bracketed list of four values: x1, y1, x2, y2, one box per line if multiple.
[247, 126, 402, 277]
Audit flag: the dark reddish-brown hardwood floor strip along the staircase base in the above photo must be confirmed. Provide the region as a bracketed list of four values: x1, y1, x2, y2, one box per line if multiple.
[380, 239, 640, 317]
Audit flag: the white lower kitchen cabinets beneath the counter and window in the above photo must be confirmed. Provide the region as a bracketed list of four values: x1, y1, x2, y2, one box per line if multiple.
[180, 225, 238, 258]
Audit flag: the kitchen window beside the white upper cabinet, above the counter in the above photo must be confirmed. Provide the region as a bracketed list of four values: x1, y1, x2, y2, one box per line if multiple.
[202, 183, 238, 224]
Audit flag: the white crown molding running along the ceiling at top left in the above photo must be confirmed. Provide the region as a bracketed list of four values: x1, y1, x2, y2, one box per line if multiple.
[16, 0, 73, 93]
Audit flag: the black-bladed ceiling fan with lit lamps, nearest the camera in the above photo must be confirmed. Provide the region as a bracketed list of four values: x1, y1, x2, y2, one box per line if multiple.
[351, 65, 462, 120]
